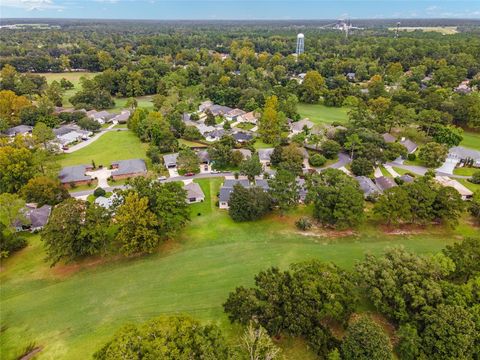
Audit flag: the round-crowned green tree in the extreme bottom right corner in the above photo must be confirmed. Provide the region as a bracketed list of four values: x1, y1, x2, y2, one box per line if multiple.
[422, 304, 478, 360]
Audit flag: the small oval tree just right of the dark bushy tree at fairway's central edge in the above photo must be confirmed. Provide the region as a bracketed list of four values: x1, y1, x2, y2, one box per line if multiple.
[268, 169, 300, 213]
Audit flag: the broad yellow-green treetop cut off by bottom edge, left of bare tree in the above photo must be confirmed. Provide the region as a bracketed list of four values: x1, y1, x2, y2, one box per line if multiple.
[93, 315, 231, 360]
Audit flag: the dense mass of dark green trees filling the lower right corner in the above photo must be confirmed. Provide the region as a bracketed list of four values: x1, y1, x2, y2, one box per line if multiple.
[224, 239, 480, 360]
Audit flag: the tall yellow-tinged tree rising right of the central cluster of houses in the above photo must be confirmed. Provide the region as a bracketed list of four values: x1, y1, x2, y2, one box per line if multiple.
[258, 95, 284, 144]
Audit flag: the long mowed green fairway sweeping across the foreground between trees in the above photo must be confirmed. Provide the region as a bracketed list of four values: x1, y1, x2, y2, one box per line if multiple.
[0, 178, 478, 360]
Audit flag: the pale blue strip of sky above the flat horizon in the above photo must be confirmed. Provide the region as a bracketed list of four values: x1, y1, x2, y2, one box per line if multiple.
[0, 0, 480, 20]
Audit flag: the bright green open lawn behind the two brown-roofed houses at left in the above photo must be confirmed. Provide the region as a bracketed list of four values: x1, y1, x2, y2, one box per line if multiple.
[59, 131, 147, 166]
